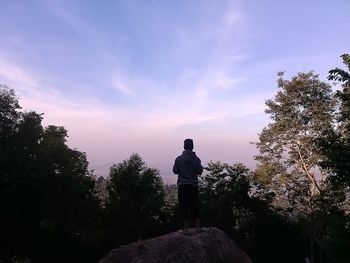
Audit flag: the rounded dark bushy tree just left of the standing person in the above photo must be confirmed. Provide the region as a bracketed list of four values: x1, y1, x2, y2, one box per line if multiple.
[106, 154, 164, 246]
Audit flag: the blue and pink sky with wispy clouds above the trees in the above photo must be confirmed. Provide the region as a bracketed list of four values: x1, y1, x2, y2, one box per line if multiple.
[0, 0, 350, 183]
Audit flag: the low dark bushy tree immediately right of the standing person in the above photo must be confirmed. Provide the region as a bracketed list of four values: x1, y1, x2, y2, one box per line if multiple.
[200, 162, 305, 263]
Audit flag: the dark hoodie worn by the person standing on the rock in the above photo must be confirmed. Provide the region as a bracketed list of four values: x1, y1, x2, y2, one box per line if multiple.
[173, 150, 203, 186]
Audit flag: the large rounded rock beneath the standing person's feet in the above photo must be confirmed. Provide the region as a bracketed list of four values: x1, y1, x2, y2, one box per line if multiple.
[100, 227, 252, 263]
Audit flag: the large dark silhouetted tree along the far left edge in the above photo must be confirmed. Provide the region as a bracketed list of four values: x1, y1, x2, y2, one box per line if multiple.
[0, 86, 100, 262]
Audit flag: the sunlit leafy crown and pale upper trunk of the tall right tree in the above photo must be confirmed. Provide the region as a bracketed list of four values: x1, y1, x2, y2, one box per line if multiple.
[256, 72, 334, 204]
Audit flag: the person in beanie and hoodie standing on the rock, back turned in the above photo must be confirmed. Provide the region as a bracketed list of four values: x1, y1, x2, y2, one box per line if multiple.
[173, 139, 203, 235]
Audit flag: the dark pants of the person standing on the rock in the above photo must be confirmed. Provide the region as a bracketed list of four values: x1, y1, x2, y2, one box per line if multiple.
[178, 184, 199, 220]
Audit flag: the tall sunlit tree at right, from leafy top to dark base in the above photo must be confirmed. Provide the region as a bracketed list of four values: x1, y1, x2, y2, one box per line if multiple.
[253, 72, 350, 262]
